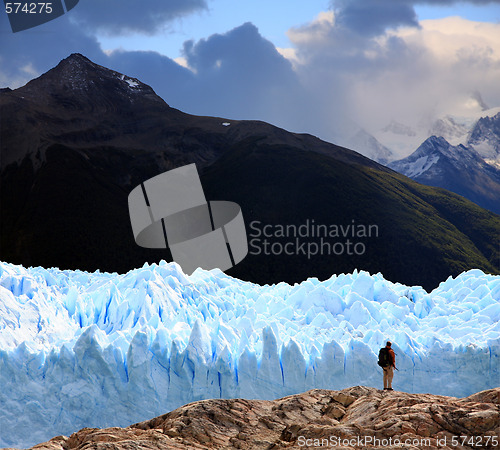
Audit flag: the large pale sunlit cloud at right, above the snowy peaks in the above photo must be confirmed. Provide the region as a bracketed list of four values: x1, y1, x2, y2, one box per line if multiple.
[289, 7, 500, 140]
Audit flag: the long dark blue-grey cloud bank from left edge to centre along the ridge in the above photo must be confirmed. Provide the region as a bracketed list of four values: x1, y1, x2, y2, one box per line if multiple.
[0, 14, 307, 131]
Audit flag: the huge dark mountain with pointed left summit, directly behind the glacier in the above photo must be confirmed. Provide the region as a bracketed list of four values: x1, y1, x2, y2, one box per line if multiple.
[0, 54, 500, 289]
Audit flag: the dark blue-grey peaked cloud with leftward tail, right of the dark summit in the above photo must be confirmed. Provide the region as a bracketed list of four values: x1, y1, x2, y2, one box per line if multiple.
[99, 23, 308, 131]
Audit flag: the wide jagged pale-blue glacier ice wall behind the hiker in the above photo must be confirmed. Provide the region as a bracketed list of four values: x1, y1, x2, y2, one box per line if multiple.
[0, 262, 500, 447]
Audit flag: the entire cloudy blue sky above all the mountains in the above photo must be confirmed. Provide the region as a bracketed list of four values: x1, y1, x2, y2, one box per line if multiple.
[0, 0, 500, 156]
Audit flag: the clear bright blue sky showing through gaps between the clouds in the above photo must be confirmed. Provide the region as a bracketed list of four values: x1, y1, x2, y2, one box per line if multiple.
[99, 0, 500, 58]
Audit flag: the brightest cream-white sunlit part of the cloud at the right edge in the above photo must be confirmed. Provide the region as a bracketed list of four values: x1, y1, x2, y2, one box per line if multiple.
[380, 17, 500, 114]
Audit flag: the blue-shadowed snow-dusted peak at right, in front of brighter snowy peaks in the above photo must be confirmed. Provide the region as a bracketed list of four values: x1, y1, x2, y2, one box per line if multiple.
[388, 136, 500, 214]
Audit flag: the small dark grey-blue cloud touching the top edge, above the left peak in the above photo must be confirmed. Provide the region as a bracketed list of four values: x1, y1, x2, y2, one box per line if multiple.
[71, 0, 207, 35]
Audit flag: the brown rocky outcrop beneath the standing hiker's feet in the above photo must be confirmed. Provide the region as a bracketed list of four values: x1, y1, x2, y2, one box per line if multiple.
[24, 386, 500, 450]
